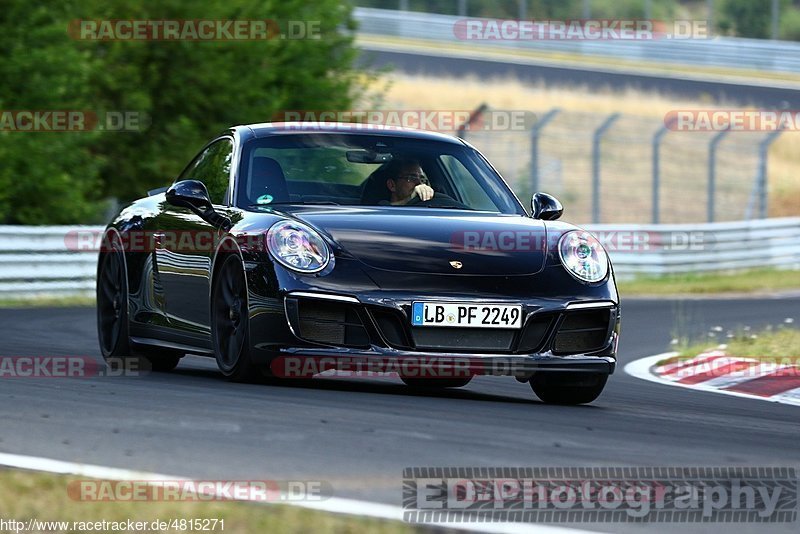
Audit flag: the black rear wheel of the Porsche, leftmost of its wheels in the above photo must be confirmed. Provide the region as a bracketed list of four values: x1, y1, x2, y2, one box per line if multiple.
[96, 238, 132, 367]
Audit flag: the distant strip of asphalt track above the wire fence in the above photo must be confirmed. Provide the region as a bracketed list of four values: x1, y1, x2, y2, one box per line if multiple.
[361, 48, 800, 110]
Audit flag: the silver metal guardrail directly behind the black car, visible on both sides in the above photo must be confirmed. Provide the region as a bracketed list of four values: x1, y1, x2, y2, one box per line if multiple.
[0, 217, 800, 298]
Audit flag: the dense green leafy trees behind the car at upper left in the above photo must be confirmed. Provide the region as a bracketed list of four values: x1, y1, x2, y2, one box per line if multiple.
[0, 0, 366, 224]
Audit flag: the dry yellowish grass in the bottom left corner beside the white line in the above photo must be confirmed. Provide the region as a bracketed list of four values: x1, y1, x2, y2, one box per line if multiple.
[0, 468, 423, 534]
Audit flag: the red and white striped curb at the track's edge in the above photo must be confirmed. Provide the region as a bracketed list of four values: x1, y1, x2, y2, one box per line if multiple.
[625, 350, 800, 406]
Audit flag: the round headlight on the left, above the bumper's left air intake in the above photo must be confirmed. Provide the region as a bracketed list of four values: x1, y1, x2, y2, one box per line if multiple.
[267, 221, 331, 273]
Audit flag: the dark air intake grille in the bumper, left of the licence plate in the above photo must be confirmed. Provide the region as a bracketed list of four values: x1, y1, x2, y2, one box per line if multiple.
[286, 298, 369, 347]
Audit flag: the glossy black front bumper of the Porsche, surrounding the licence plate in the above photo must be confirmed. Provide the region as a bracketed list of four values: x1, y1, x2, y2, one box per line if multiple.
[250, 291, 620, 380]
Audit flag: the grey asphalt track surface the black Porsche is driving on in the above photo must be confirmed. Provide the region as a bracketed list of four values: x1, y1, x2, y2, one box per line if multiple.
[0, 296, 800, 532]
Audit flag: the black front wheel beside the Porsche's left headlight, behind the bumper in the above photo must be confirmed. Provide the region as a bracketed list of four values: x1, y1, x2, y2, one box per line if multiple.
[211, 255, 260, 382]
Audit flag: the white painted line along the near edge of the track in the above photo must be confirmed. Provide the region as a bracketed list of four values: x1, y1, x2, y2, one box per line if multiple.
[0, 452, 595, 534]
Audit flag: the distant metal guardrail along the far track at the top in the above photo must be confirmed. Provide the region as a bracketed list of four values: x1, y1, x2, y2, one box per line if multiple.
[354, 7, 800, 72]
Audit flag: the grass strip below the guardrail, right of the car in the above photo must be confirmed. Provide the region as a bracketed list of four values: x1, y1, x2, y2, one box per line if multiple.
[617, 269, 800, 298]
